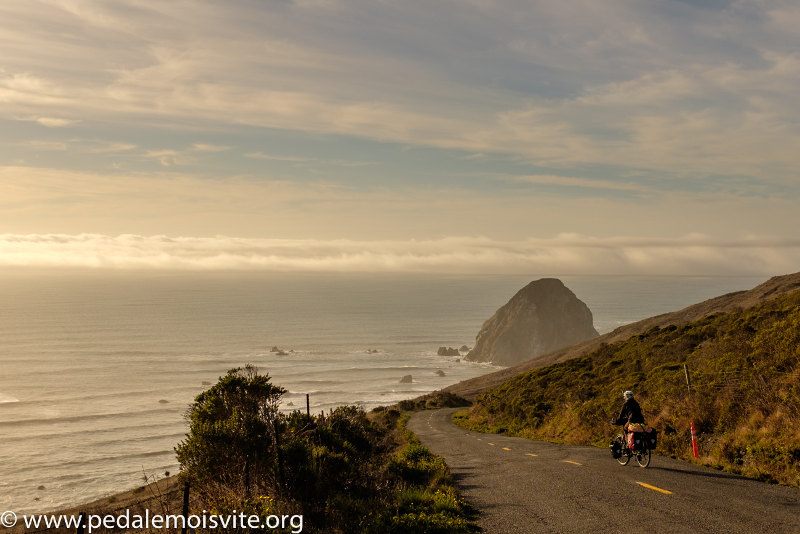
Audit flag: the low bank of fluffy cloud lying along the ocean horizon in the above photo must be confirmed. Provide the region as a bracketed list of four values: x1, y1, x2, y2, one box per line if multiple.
[0, 234, 800, 275]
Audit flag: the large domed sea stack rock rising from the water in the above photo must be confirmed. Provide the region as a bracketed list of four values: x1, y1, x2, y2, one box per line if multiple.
[466, 278, 598, 366]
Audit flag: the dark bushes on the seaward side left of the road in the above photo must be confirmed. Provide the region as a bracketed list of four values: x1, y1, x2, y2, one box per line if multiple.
[176, 366, 475, 534]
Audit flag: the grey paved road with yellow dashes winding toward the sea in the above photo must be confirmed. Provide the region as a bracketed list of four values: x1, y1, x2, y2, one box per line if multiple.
[408, 409, 800, 534]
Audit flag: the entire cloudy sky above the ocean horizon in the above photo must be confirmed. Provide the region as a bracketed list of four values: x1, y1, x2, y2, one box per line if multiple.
[0, 0, 800, 275]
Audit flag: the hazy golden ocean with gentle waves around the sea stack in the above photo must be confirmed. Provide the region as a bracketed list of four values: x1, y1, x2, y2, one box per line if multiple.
[0, 271, 764, 514]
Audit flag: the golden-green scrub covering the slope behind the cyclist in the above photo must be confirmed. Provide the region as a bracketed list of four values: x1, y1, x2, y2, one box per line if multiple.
[456, 292, 800, 486]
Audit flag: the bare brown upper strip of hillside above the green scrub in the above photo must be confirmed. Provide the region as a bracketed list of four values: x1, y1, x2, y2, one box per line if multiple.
[445, 273, 800, 399]
